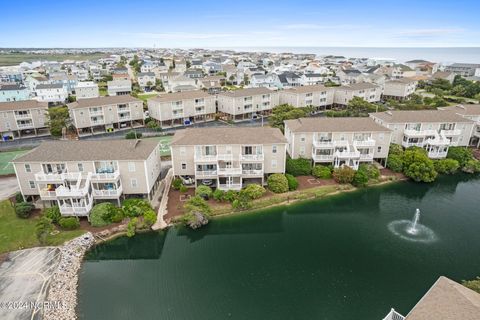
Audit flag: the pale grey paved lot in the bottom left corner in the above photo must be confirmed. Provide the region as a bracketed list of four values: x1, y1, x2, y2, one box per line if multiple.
[0, 247, 60, 320]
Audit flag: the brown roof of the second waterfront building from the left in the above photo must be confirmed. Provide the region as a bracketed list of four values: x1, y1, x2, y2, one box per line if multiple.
[172, 127, 287, 146]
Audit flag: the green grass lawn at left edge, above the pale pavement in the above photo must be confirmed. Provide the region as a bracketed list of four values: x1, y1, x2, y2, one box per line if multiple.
[0, 200, 85, 254]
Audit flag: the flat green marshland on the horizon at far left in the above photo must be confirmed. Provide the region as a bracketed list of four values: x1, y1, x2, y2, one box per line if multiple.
[0, 53, 107, 66]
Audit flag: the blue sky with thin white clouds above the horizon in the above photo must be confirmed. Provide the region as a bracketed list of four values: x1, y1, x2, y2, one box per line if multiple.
[0, 0, 480, 48]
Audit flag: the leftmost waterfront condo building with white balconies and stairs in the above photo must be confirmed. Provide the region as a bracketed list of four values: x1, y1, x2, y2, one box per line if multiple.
[13, 140, 161, 216]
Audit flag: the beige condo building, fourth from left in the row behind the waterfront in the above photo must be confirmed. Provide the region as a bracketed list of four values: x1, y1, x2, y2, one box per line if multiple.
[217, 88, 279, 120]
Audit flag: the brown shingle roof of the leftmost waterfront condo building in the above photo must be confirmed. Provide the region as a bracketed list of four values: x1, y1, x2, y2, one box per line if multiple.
[13, 140, 159, 162]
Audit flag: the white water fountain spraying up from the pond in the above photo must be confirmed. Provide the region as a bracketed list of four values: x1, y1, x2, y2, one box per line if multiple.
[388, 208, 437, 242]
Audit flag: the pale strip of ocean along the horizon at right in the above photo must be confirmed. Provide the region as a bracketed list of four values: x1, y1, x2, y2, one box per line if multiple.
[207, 46, 480, 64]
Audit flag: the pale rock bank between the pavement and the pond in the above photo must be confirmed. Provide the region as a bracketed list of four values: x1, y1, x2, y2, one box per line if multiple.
[43, 232, 96, 320]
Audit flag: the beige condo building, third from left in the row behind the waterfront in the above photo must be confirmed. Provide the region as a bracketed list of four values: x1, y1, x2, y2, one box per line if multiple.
[148, 91, 216, 128]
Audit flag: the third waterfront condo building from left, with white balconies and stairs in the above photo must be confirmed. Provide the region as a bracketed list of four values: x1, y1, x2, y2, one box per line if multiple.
[285, 118, 391, 170]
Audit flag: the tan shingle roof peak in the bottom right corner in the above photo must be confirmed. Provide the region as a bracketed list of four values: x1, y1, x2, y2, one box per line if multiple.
[405, 277, 480, 320]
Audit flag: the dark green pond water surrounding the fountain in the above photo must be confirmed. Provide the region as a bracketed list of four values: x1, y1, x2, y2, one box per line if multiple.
[78, 175, 480, 320]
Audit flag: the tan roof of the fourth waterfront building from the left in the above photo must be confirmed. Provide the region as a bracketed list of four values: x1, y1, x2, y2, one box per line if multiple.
[370, 110, 472, 123]
